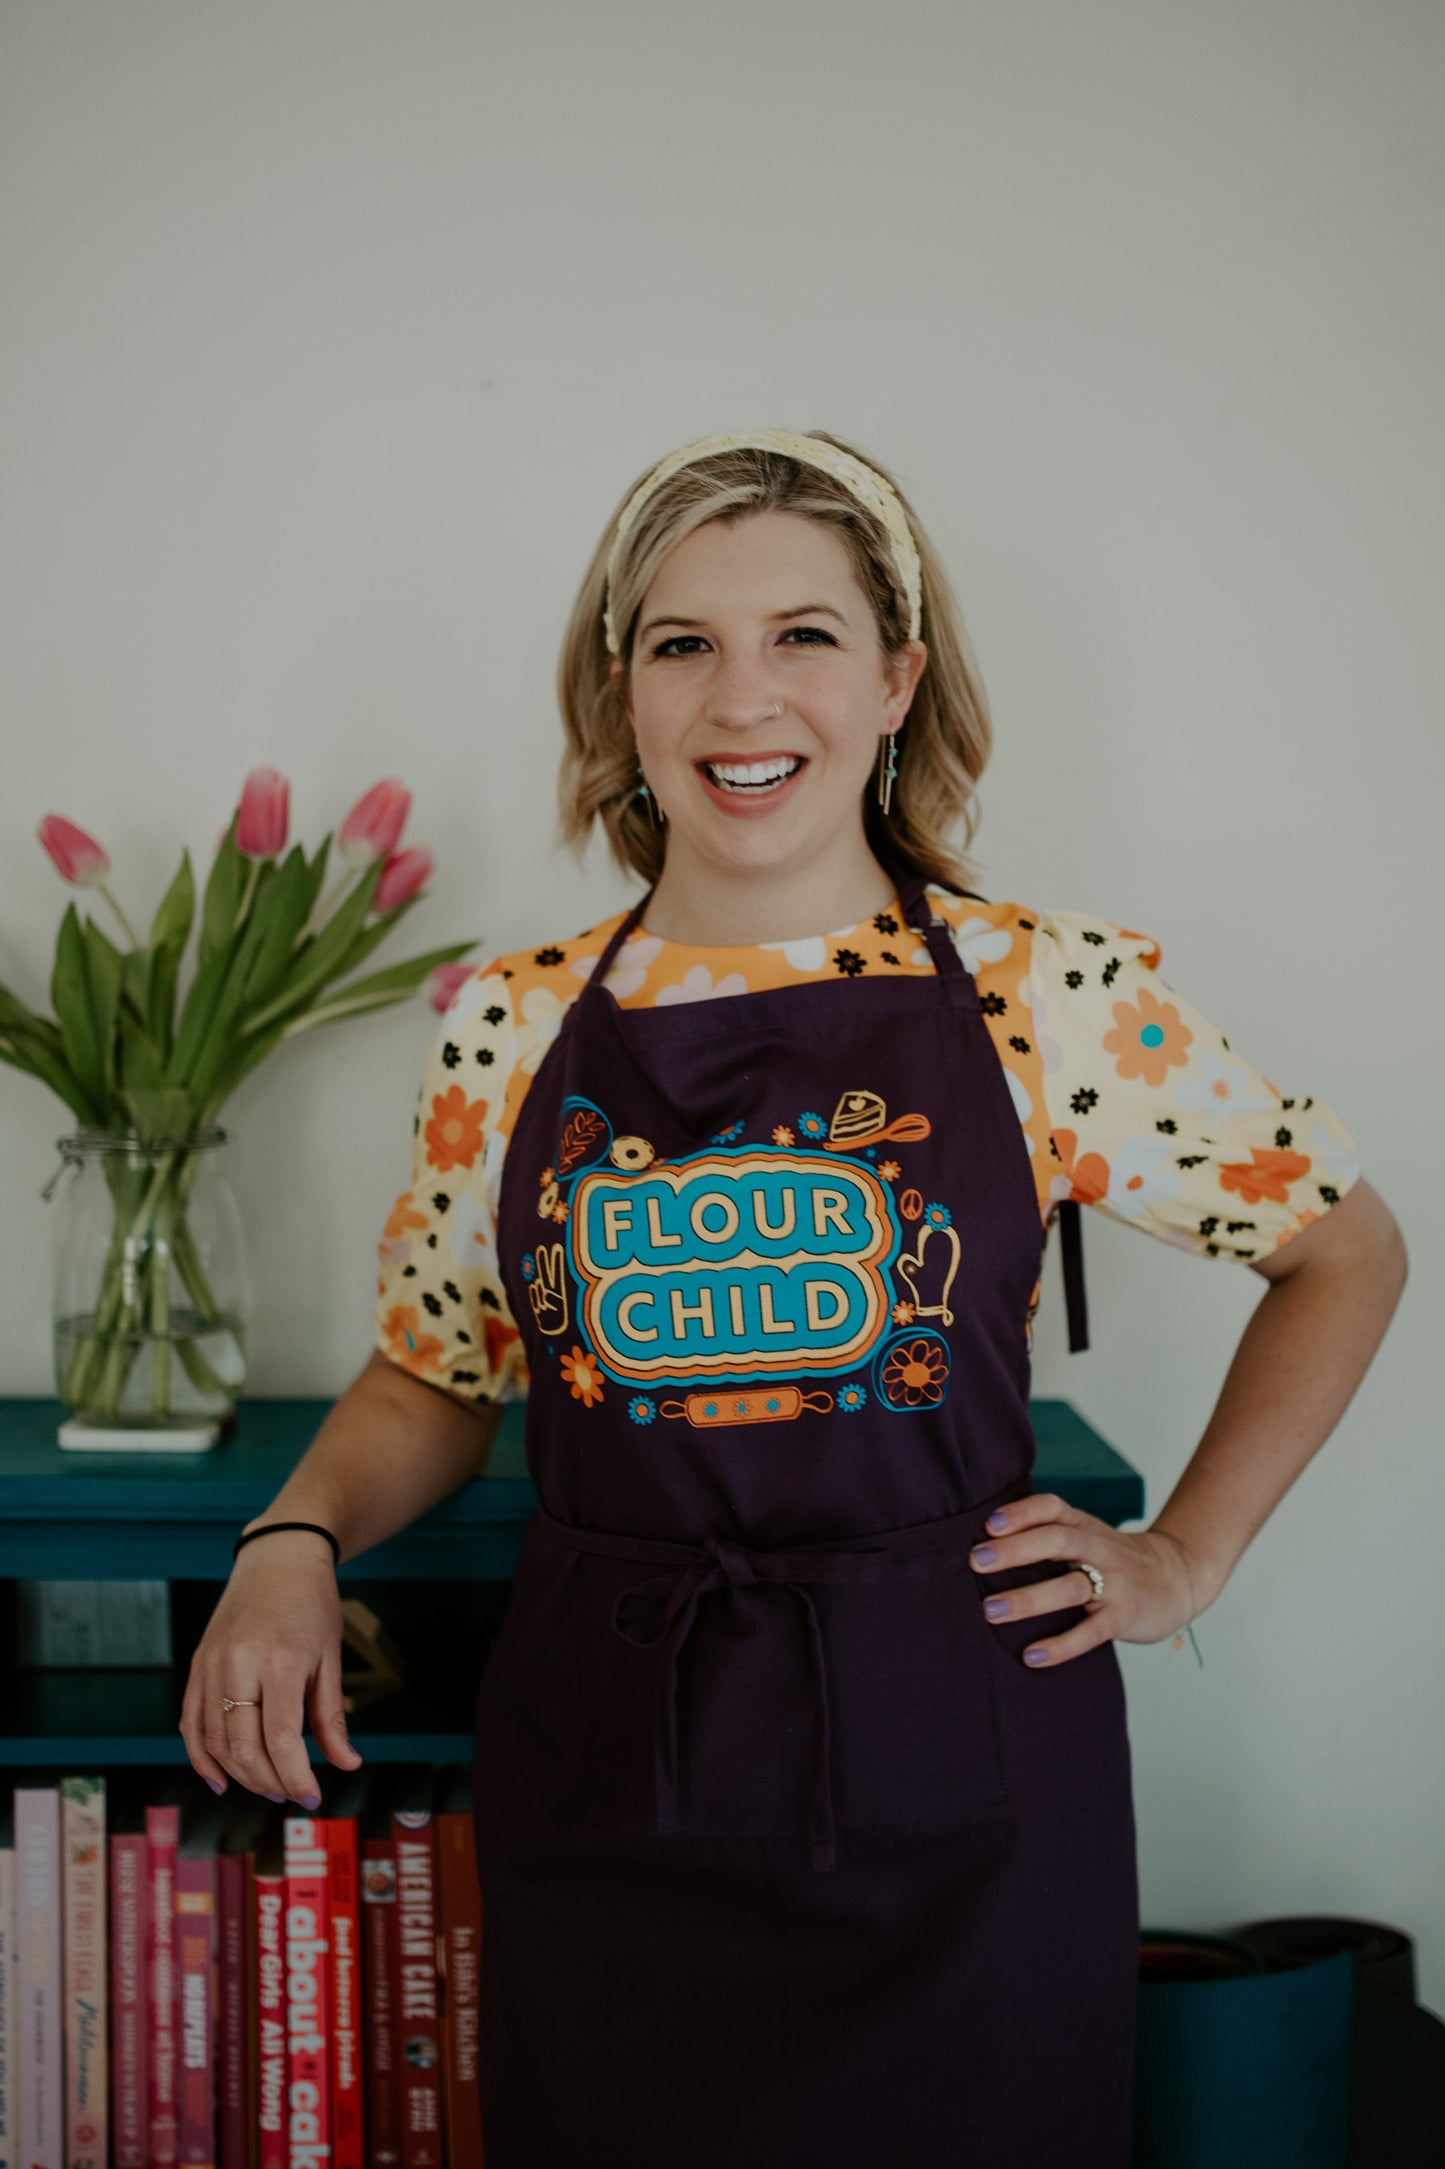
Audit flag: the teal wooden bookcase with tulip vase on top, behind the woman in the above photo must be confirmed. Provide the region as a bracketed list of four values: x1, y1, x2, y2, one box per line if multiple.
[0, 1399, 1143, 1770]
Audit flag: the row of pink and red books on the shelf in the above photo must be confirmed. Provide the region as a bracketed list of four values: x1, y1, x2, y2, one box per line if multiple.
[0, 1770, 482, 2169]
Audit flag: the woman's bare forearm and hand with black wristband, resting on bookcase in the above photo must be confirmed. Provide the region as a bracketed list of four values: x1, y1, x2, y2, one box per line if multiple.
[180, 1351, 501, 1807]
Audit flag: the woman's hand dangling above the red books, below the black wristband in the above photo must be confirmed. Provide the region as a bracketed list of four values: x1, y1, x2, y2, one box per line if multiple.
[180, 1529, 360, 1811]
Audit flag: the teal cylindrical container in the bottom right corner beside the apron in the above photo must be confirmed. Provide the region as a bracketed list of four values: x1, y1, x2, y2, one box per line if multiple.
[1135, 1930, 1354, 2169]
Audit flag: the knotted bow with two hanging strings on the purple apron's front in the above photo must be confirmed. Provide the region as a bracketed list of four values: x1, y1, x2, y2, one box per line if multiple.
[612, 1536, 890, 1872]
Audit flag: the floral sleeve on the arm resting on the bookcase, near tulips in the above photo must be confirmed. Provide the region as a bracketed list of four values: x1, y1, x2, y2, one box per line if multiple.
[375, 963, 527, 1401]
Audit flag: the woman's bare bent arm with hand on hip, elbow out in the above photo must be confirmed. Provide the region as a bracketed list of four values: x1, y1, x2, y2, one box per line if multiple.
[972, 1180, 1406, 1664]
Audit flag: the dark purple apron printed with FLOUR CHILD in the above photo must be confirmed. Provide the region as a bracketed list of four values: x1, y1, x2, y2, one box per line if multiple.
[473, 876, 1137, 2169]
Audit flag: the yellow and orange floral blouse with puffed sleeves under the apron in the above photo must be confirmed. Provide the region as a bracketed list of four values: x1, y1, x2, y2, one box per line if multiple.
[375, 887, 1358, 1401]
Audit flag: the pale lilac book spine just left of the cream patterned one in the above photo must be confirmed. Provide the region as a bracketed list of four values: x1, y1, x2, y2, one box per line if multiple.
[15, 1785, 65, 2169]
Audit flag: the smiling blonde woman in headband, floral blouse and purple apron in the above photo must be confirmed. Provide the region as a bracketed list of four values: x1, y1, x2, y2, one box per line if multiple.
[182, 432, 1404, 2169]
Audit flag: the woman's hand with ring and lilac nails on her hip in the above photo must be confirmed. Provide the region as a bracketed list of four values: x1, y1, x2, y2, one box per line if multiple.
[968, 1492, 1217, 1666]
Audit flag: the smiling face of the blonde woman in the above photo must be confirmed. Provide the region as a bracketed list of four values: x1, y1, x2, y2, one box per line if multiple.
[612, 512, 929, 870]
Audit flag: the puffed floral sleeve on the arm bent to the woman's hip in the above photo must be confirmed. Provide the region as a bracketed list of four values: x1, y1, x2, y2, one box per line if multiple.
[1028, 911, 1360, 1262]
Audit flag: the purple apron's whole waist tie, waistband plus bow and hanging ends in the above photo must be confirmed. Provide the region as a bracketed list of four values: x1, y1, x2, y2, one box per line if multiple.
[538, 1479, 1028, 1874]
